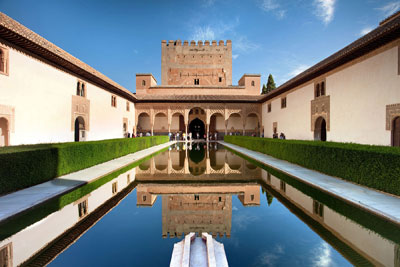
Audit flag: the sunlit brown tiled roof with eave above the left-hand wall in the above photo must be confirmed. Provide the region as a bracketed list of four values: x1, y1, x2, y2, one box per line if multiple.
[0, 12, 136, 101]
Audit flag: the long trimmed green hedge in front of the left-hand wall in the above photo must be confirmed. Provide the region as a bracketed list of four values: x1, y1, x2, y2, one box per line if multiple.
[0, 136, 168, 194]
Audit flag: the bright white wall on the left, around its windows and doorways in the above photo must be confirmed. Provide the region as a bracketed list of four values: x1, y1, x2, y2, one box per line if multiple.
[0, 42, 135, 145]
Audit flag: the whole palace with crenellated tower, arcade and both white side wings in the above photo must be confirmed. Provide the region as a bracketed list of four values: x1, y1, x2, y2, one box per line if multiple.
[0, 10, 400, 146]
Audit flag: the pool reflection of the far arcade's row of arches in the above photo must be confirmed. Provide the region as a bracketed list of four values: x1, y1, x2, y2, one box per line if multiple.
[136, 143, 261, 182]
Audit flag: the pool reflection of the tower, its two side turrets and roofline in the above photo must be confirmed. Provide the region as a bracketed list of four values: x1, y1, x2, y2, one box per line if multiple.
[136, 183, 260, 237]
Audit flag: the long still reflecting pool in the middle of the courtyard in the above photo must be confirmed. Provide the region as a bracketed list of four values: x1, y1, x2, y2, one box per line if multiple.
[0, 143, 400, 266]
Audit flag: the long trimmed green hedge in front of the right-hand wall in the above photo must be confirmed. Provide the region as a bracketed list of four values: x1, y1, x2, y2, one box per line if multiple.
[224, 136, 400, 195]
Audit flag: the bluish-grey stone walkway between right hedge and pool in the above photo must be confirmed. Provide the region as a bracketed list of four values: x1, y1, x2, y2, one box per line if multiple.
[220, 141, 400, 224]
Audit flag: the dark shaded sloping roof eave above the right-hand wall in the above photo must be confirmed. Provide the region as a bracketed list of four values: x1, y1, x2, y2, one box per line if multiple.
[262, 12, 400, 102]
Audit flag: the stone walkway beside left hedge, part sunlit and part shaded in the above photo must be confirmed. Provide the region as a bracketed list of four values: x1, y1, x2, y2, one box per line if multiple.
[0, 141, 175, 223]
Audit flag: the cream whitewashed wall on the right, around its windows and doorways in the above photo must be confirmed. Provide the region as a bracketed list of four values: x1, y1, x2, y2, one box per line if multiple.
[262, 40, 400, 145]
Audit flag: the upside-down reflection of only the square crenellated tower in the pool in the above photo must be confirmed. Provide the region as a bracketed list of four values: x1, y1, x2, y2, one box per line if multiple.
[162, 194, 232, 240]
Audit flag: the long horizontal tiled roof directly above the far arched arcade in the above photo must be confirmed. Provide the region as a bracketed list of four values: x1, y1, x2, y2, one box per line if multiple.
[136, 95, 262, 103]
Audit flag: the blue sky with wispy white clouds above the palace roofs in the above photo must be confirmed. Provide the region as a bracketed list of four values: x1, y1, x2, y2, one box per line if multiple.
[0, 0, 400, 92]
